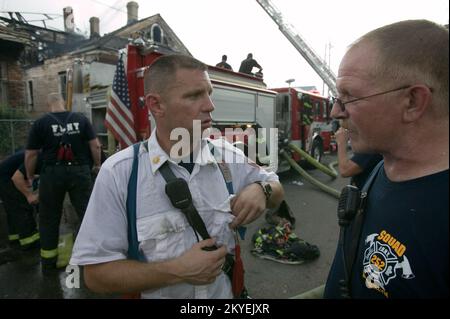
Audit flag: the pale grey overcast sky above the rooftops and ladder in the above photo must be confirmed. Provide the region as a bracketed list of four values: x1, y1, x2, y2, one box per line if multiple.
[0, 0, 449, 95]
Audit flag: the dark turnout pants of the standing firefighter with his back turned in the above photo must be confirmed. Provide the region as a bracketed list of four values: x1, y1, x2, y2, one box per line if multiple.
[39, 165, 92, 268]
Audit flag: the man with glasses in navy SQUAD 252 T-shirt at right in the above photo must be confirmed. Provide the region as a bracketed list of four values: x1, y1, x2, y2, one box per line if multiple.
[324, 20, 449, 299]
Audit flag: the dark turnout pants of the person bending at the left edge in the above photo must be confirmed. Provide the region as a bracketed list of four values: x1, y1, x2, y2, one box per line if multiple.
[0, 180, 39, 249]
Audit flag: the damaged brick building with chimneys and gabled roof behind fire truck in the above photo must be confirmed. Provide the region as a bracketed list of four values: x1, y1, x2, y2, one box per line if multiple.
[0, 1, 190, 118]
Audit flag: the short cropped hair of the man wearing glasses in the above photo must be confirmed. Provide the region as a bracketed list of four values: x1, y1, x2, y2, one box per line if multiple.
[349, 20, 449, 115]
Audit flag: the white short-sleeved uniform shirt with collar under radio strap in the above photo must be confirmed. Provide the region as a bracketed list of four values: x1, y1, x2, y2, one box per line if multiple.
[70, 132, 278, 299]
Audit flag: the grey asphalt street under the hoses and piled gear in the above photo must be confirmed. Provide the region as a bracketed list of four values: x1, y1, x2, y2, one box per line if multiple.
[0, 155, 347, 299]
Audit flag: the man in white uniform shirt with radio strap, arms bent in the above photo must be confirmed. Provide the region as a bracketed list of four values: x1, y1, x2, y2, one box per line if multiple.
[71, 55, 284, 298]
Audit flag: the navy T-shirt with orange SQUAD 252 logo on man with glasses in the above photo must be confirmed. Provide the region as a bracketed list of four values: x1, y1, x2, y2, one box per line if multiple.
[324, 169, 449, 299]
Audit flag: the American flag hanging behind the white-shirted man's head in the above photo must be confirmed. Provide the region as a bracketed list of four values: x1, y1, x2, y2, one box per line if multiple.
[105, 55, 136, 149]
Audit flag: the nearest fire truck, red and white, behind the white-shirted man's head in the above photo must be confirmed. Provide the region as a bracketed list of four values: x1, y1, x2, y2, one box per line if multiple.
[126, 44, 278, 171]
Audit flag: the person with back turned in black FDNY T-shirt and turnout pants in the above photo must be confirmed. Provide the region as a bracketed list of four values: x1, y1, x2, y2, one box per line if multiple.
[25, 93, 100, 274]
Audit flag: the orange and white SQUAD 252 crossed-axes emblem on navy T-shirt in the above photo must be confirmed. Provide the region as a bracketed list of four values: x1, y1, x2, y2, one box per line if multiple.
[363, 230, 414, 297]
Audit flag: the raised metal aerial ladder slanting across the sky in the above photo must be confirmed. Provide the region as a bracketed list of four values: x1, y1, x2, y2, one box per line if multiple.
[256, 0, 337, 96]
